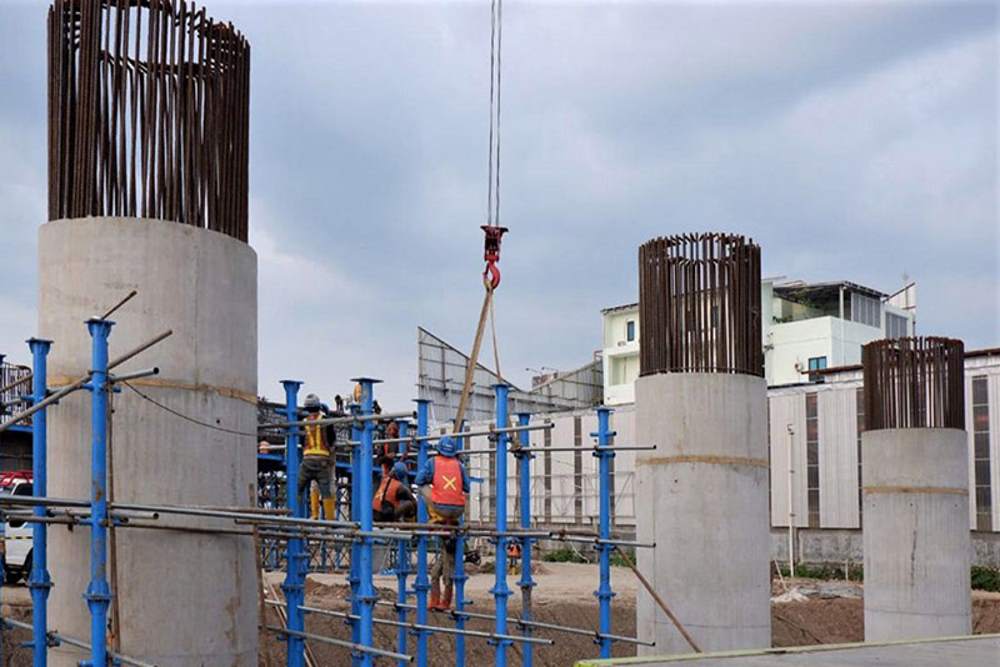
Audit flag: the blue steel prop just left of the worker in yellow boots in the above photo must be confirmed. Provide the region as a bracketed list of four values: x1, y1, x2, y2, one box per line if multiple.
[281, 380, 308, 667]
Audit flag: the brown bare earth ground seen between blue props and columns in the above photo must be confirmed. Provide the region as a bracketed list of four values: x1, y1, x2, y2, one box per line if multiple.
[0, 563, 1000, 667]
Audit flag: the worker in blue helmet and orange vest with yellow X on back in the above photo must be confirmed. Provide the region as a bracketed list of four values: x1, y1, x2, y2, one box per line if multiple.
[416, 435, 469, 611]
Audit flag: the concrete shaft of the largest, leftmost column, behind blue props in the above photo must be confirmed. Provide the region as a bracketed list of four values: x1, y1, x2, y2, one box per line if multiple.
[39, 218, 258, 667]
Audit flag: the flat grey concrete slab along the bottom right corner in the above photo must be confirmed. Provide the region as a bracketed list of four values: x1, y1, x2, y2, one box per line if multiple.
[576, 635, 1000, 667]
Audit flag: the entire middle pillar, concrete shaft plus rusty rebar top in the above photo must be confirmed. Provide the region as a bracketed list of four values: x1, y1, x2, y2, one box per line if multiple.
[636, 234, 771, 655]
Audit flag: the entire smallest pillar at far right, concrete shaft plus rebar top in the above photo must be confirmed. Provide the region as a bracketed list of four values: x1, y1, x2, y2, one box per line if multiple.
[861, 338, 972, 641]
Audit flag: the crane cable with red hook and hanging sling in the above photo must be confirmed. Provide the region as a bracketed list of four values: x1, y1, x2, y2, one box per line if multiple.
[453, 0, 507, 433]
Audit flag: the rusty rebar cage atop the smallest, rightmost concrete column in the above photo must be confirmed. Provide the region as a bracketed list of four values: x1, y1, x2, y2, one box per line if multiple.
[861, 336, 965, 431]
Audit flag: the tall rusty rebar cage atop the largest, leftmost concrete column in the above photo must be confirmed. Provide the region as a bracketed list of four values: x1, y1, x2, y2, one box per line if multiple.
[48, 0, 250, 241]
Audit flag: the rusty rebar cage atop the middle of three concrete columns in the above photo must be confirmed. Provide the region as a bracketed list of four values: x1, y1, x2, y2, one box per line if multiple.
[639, 233, 764, 377]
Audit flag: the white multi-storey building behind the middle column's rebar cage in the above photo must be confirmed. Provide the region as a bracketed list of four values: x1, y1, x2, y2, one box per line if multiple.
[601, 279, 916, 405]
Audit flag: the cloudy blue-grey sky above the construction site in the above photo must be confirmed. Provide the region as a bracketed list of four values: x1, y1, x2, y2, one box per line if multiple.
[0, 0, 1000, 408]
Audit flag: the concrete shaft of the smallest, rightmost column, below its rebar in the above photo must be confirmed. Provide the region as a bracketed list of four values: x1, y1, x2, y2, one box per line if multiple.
[861, 428, 972, 641]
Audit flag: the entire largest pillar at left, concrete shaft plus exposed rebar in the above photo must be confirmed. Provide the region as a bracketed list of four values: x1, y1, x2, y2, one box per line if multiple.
[39, 0, 258, 667]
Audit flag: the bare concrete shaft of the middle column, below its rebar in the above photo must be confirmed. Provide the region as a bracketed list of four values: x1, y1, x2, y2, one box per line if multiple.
[635, 373, 771, 655]
